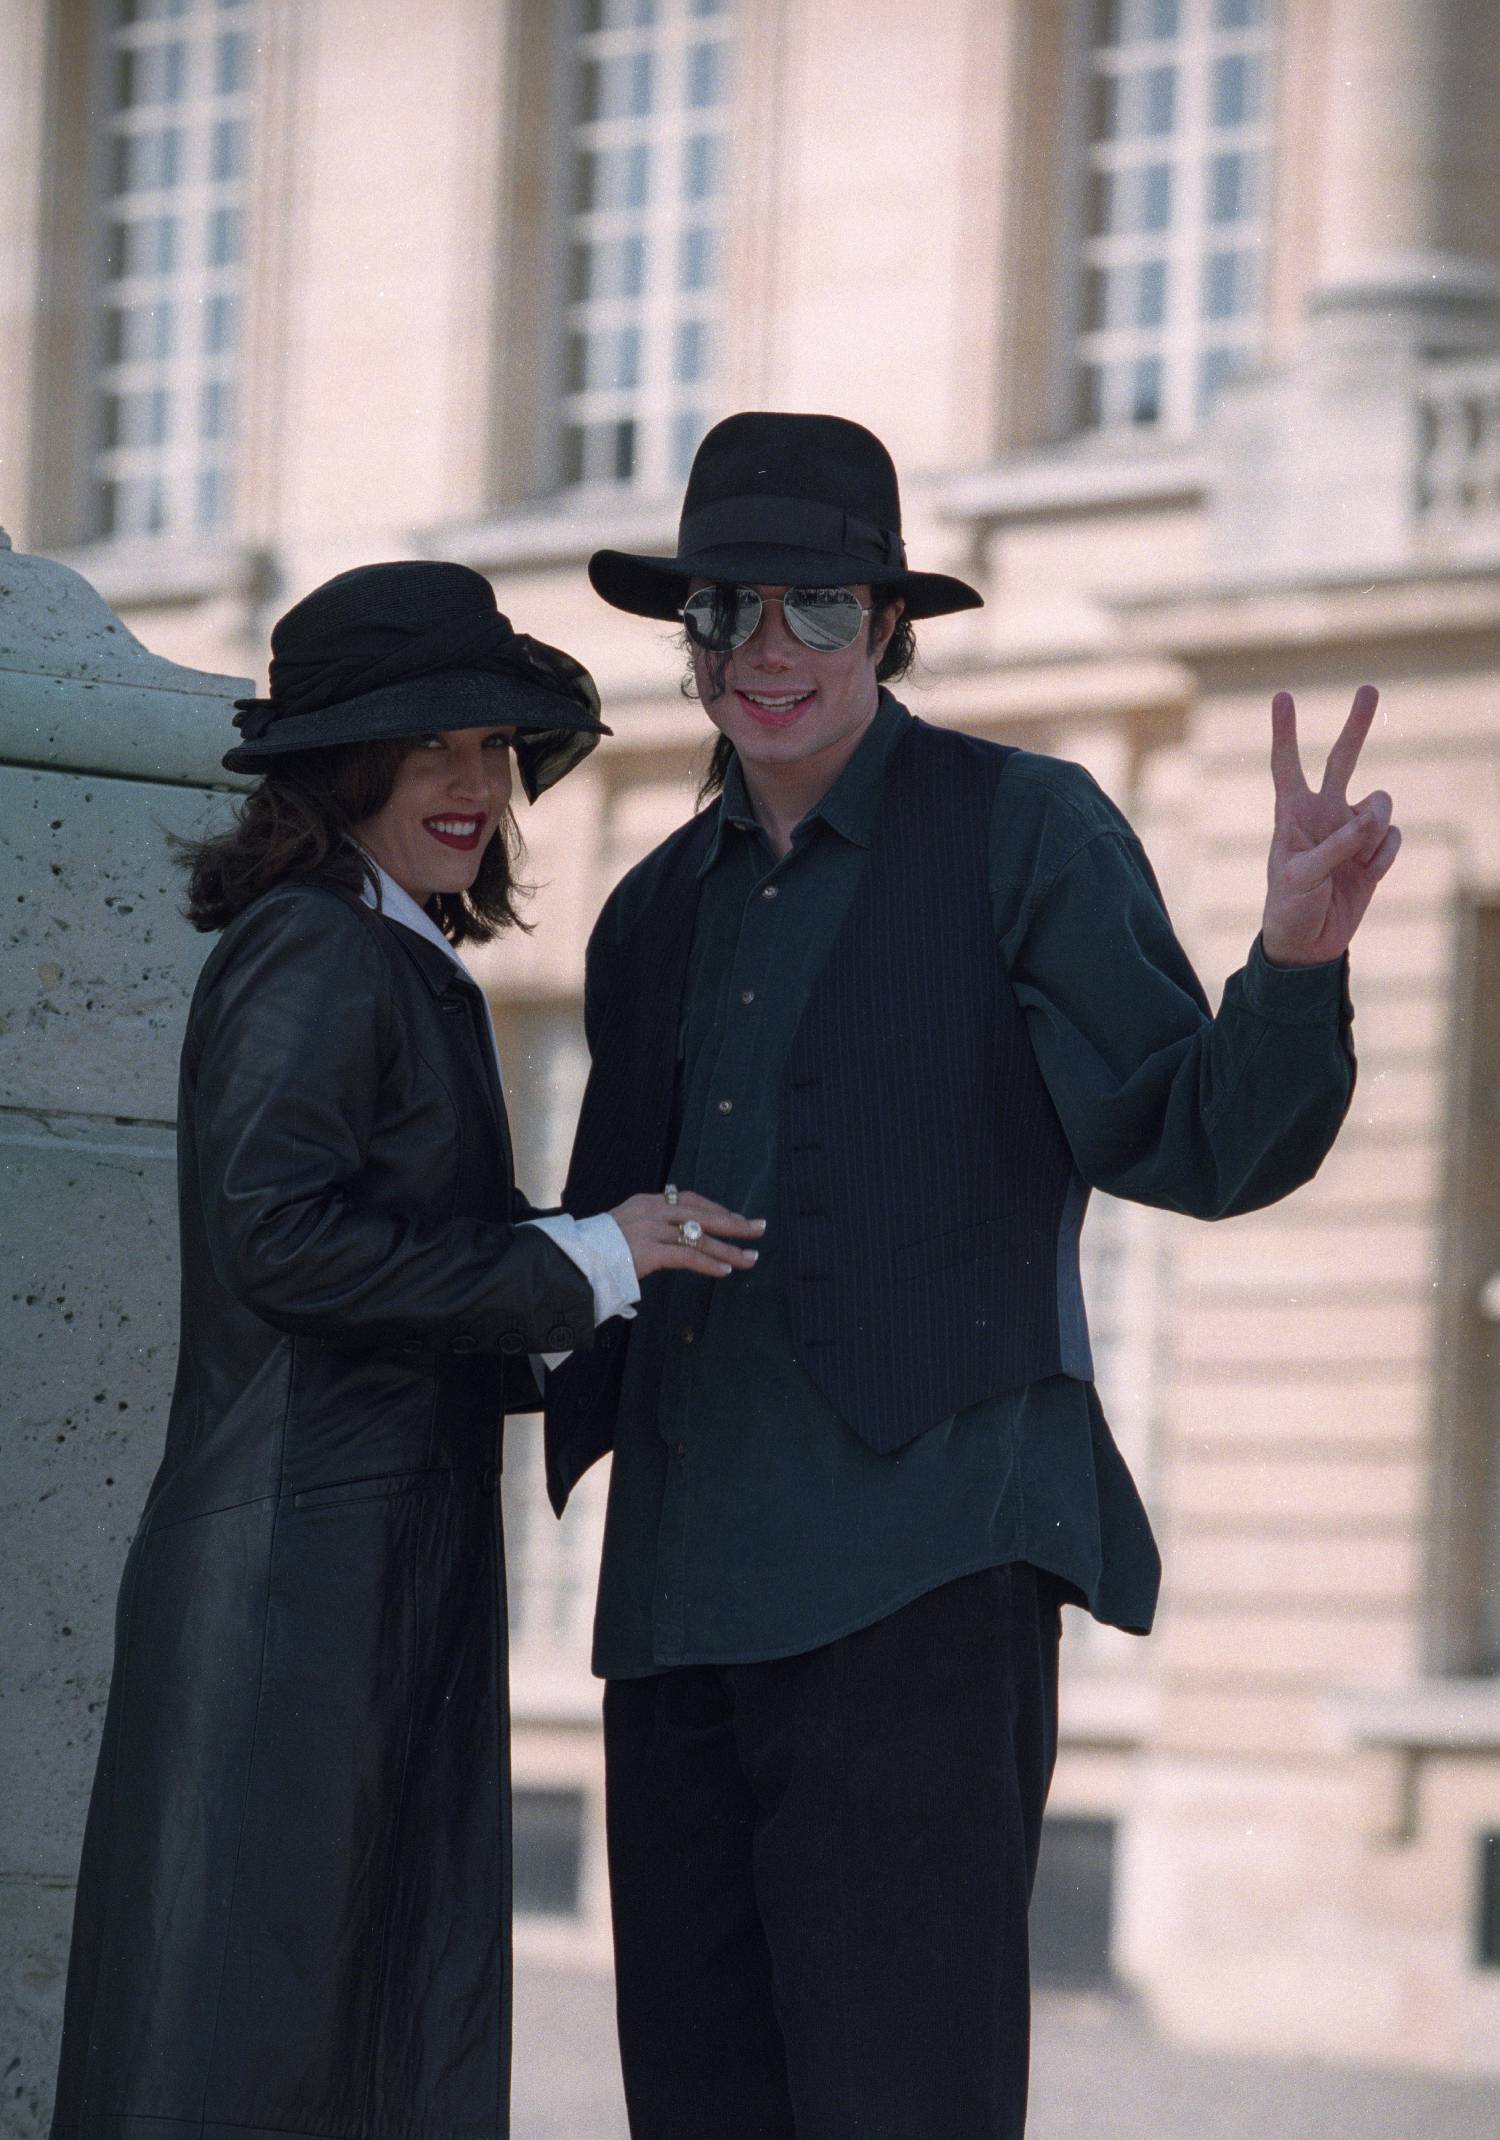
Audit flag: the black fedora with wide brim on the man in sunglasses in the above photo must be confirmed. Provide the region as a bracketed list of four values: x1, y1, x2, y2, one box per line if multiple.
[588, 411, 984, 618]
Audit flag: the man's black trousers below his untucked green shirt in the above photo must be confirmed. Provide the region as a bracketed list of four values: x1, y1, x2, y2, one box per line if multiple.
[603, 1564, 1059, 2140]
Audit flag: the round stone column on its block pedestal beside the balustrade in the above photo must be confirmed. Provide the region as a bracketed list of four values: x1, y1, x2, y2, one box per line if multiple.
[1211, 0, 1500, 578]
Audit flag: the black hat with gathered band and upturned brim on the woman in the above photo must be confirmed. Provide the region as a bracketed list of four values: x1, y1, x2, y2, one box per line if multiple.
[223, 559, 610, 803]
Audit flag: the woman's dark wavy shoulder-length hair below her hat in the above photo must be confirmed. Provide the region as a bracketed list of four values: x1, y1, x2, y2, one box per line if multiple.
[169, 736, 531, 944]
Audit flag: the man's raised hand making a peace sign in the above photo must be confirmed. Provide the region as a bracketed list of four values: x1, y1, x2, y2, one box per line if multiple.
[1260, 683, 1402, 965]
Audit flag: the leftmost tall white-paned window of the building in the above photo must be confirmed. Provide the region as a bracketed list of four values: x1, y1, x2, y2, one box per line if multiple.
[92, 0, 255, 537]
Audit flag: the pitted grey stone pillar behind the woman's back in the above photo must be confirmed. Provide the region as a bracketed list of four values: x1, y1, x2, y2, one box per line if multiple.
[0, 533, 250, 2140]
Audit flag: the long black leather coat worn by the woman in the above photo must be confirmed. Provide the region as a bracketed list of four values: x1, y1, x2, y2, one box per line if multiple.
[53, 886, 593, 2140]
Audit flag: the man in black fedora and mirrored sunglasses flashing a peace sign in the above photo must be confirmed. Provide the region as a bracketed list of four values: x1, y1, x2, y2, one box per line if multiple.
[548, 413, 1399, 2140]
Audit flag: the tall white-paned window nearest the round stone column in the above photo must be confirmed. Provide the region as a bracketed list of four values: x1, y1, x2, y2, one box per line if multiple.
[1074, 0, 1273, 432]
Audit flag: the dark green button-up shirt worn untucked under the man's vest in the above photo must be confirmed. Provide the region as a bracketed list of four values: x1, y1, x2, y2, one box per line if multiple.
[595, 693, 1352, 1678]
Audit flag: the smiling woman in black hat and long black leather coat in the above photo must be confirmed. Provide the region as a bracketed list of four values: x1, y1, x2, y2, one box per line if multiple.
[53, 563, 755, 2140]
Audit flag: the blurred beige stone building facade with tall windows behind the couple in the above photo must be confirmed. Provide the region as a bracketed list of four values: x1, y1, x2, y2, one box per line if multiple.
[0, 0, 1500, 2074]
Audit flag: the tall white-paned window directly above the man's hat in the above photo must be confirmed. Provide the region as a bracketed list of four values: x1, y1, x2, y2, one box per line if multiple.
[558, 0, 732, 490]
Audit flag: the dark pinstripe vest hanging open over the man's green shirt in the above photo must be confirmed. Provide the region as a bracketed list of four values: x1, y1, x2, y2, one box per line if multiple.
[548, 721, 1091, 1507]
